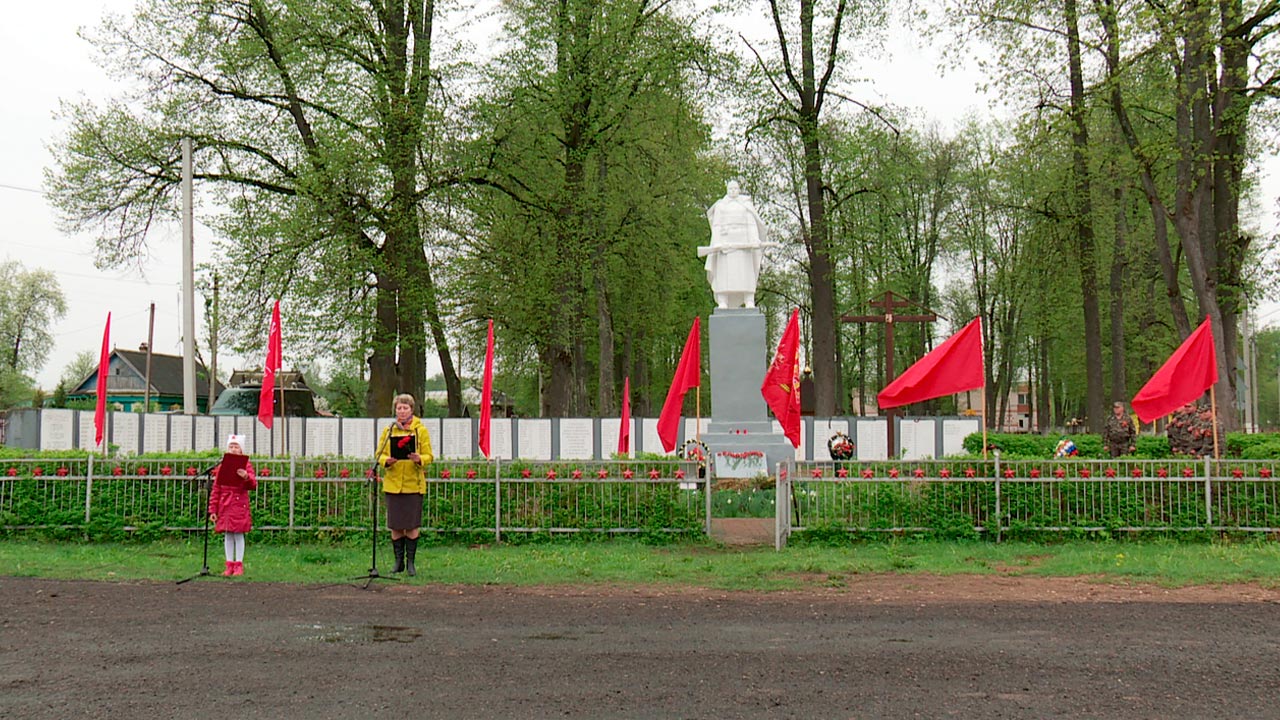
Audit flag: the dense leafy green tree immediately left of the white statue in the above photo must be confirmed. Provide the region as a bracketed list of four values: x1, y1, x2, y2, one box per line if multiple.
[468, 0, 712, 416]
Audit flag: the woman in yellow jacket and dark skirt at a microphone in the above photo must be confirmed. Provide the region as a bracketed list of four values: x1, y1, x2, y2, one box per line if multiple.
[378, 395, 435, 575]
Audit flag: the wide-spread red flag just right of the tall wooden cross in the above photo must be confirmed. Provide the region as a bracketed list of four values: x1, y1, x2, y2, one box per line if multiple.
[876, 316, 986, 409]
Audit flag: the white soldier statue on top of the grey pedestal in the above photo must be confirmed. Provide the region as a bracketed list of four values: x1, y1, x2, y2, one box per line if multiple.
[698, 181, 776, 307]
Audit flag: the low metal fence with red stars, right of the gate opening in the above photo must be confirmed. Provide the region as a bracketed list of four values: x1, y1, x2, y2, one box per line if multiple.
[776, 456, 1280, 547]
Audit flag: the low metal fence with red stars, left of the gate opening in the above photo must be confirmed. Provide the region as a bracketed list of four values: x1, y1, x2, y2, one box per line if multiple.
[0, 457, 712, 539]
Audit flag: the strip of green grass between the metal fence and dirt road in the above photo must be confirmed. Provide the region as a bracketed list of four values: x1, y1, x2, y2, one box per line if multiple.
[0, 537, 1280, 592]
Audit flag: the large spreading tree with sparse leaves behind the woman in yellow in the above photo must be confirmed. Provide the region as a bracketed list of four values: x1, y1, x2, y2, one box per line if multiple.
[49, 0, 461, 414]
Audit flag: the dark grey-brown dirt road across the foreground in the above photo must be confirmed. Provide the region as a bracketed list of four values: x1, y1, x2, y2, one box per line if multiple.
[0, 575, 1280, 719]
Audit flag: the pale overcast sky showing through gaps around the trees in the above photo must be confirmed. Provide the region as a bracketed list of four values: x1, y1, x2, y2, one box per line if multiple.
[0, 0, 1280, 389]
